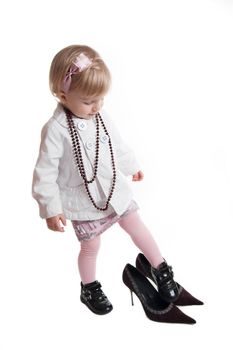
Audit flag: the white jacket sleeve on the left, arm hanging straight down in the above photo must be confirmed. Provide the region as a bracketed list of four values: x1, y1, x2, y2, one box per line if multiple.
[32, 122, 63, 218]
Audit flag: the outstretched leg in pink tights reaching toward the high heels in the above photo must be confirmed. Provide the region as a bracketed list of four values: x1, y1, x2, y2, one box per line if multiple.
[118, 211, 164, 268]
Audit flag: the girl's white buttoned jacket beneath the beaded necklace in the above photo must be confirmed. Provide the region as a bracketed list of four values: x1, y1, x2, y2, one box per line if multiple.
[32, 104, 139, 220]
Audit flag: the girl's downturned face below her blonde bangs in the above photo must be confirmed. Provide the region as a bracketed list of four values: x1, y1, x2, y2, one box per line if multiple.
[60, 90, 104, 119]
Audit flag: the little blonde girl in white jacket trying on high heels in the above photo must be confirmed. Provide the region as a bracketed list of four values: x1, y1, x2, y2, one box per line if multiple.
[33, 45, 178, 315]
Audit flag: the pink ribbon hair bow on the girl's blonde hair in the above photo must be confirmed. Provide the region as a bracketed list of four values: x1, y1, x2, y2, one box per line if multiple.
[63, 53, 92, 93]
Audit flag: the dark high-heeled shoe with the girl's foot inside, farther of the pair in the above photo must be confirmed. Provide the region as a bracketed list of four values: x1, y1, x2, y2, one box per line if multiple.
[136, 253, 204, 306]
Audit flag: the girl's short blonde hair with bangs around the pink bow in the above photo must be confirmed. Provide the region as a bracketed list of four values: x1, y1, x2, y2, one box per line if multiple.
[49, 45, 111, 97]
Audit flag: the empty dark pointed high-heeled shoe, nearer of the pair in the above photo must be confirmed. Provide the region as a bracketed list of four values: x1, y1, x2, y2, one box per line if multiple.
[122, 264, 196, 324]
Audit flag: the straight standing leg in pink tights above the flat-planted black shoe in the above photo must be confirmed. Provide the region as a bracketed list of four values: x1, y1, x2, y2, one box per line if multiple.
[78, 236, 100, 284]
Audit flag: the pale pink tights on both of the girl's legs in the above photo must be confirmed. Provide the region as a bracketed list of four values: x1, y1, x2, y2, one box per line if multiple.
[78, 211, 164, 284]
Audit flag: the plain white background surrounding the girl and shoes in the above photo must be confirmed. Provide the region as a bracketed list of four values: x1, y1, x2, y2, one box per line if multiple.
[0, 0, 233, 350]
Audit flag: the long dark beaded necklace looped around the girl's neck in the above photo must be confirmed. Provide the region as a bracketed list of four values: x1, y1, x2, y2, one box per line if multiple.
[64, 108, 116, 211]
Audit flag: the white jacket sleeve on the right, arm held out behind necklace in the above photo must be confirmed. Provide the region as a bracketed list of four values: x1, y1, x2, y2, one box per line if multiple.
[104, 113, 140, 176]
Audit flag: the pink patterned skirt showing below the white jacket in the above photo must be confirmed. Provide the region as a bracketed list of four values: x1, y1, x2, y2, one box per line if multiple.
[72, 201, 138, 241]
